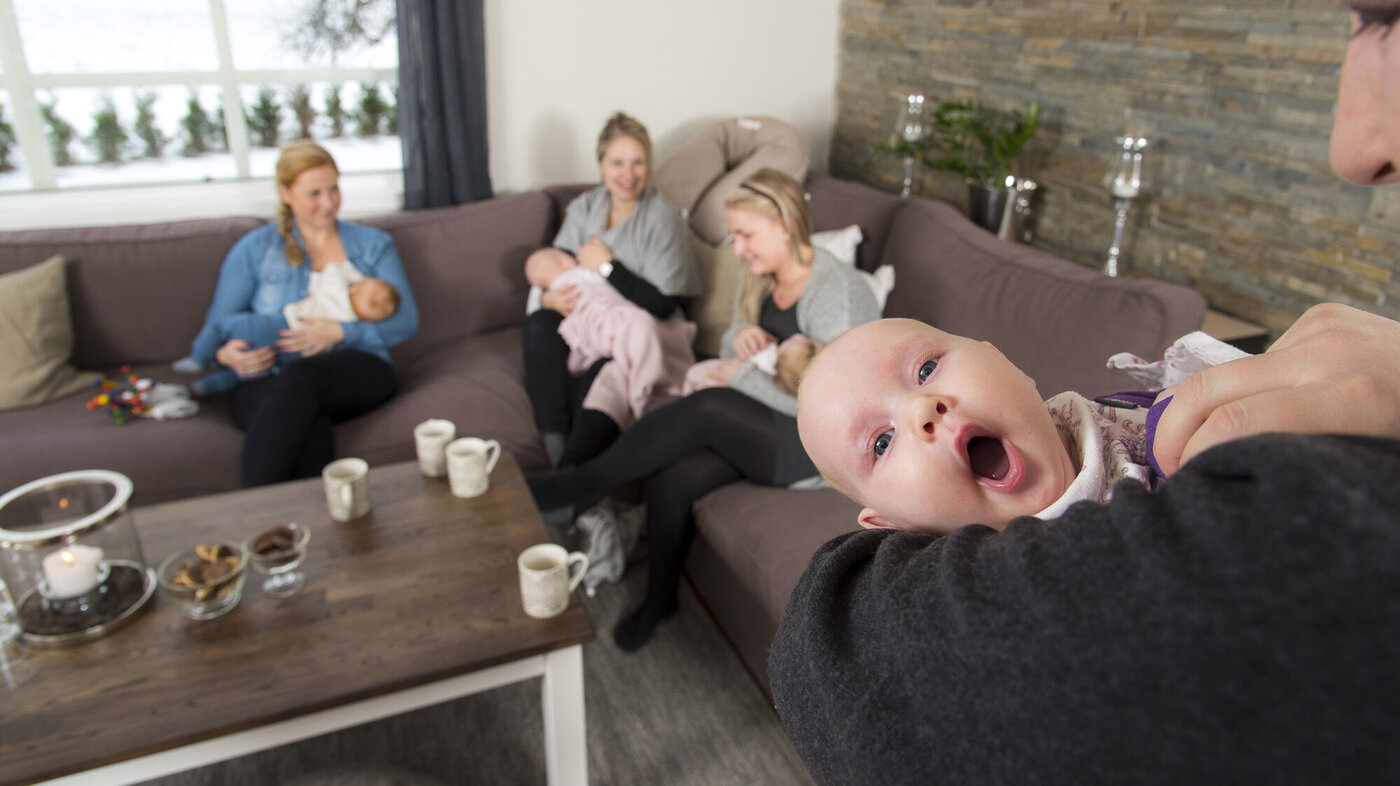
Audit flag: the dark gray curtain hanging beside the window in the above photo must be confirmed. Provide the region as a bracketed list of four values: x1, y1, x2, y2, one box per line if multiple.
[398, 0, 491, 210]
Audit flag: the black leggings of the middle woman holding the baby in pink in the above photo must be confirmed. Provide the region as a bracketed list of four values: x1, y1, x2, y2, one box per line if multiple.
[524, 308, 619, 467]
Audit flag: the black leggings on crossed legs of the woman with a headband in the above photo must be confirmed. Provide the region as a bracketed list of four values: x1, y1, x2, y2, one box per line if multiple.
[529, 388, 777, 605]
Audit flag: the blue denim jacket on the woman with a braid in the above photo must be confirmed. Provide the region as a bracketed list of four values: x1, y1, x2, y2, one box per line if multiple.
[204, 220, 419, 361]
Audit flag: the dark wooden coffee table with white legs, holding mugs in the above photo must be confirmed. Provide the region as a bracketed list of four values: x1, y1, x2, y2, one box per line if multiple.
[0, 454, 594, 786]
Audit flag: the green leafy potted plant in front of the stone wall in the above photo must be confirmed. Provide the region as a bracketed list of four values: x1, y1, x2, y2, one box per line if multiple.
[883, 101, 1040, 233]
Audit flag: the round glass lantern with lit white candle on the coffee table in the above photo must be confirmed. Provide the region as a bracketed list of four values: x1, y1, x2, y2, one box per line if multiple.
[0, 469, 155, 646]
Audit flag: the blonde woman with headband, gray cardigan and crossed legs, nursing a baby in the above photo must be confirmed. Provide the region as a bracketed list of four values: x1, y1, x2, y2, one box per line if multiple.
[529, 170, 879, 650]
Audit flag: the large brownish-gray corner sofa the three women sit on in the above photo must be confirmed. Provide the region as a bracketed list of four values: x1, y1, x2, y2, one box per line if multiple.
[0, 175, 1205, 688]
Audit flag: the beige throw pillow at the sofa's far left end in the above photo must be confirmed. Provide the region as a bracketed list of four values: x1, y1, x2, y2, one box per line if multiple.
[0, 256, 92, 411]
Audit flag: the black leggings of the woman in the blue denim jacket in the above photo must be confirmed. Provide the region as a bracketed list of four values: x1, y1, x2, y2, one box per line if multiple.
[234, 349, 398, 488]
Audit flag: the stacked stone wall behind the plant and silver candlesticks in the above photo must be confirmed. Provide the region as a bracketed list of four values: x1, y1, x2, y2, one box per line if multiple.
[830, 0, 1400, 335]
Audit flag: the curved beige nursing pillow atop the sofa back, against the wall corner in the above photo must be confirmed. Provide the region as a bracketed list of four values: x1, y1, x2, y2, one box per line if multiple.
[652, 118, 808, 245]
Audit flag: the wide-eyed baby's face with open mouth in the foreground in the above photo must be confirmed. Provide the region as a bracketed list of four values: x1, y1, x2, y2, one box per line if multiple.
[798, 319, 1077, 532]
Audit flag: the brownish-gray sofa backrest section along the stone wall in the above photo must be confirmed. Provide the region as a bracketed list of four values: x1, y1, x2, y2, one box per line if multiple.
[885, 199, 1205, 398]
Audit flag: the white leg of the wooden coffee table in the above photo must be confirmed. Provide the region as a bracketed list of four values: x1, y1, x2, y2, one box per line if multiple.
[542, 644, 588, 786]
